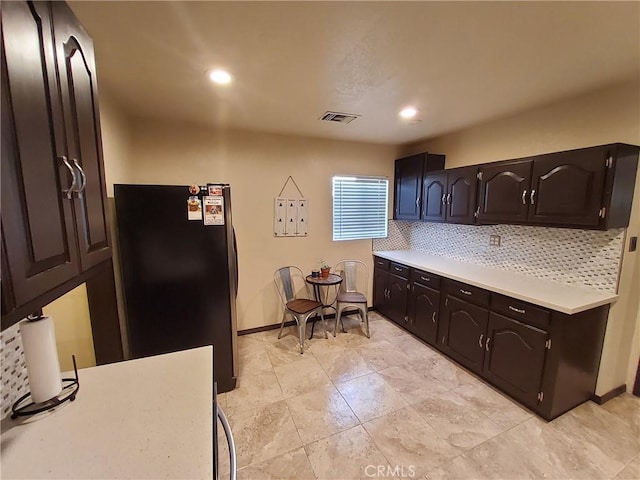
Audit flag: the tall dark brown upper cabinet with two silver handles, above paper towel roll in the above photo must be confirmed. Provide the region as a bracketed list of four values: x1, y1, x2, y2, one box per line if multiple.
[1, 2, 111, 327]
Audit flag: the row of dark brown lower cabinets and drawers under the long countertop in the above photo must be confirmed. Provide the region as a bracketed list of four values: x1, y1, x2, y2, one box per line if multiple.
[374, 257, 609, 420]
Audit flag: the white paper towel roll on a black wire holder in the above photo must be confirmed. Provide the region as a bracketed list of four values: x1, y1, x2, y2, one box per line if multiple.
[20, 317, 62, 403]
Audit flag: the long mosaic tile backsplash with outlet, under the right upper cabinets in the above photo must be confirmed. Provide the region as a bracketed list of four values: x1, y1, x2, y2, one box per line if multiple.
[373, 220, 625, 293]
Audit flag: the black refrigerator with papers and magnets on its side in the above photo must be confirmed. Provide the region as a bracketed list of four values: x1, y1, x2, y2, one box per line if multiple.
[114, 184, 238, 392]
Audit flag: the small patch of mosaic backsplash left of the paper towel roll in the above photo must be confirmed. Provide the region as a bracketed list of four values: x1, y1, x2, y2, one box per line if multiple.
[0, 323, 29, 418]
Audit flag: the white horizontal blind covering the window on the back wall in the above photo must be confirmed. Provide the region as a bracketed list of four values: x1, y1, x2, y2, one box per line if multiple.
[333, 176, 389, 240]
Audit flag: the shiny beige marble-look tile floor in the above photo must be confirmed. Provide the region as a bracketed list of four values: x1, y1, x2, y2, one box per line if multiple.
[219, 313, 640, 480]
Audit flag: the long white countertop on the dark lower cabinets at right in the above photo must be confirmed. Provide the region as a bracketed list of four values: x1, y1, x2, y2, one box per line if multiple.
[373, 250, 618, 314]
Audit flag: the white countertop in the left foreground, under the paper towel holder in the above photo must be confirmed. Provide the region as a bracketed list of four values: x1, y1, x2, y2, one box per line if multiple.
[0, 346, 213, 479]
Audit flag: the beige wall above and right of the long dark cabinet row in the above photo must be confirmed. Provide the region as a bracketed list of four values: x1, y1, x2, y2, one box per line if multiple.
[403, 79, 640, 395]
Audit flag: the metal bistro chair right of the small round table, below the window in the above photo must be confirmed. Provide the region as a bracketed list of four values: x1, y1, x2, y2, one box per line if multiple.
[333, 260, 370, 338]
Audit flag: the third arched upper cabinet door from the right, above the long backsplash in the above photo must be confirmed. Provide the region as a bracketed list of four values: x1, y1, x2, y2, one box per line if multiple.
[446, 167, 478, 224]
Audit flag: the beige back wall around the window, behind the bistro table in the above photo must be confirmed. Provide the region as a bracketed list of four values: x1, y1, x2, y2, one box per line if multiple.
[131, 120, 397, 330]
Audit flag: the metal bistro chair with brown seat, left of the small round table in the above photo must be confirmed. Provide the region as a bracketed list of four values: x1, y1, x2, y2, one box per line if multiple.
[273, 266, 327, 354]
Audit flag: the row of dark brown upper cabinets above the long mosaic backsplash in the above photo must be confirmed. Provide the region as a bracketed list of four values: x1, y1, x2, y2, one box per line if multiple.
[394, 143, 640, 230]
